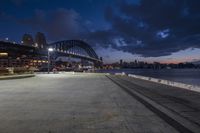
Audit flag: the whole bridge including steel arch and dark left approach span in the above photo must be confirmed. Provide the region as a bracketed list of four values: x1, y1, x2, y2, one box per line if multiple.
[0, 40, 102, 66]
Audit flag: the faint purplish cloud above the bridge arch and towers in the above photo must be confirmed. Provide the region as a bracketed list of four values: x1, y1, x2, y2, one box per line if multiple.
[19, 8, 85, 40]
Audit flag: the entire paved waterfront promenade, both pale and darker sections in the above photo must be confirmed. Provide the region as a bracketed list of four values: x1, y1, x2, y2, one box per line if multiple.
[0, 73, 200, 133]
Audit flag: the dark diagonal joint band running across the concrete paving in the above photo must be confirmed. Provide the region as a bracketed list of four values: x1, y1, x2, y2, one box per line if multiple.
[106, 76, 200, 133]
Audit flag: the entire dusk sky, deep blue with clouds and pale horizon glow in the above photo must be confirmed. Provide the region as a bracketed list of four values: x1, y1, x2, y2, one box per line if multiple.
[0, 0, 200, 63]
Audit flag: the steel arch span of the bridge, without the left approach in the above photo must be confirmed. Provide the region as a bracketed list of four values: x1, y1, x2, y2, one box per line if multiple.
[48, 40, 102, 63]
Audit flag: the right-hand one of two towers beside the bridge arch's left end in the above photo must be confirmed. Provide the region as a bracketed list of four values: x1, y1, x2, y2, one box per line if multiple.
[35, 32, 47, 49]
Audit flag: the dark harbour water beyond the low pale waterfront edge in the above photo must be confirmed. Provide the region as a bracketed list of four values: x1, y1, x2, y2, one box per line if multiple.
[98, 69, 200, 86]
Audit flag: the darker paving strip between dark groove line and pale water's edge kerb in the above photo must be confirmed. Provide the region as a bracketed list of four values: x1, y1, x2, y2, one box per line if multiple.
[111, 76, 200, 132]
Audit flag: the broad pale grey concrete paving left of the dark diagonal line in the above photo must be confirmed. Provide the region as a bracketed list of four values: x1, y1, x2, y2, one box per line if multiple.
[0, 73, 177, 133]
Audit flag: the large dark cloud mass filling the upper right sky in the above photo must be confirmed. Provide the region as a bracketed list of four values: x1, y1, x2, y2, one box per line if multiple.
[97, 0, 200, 57]
